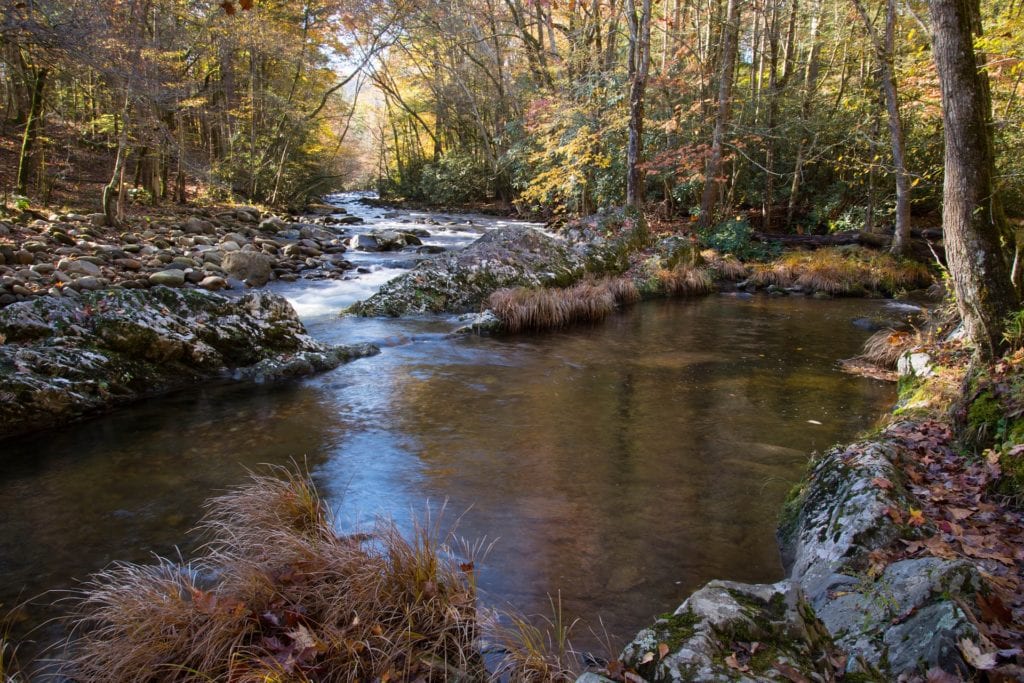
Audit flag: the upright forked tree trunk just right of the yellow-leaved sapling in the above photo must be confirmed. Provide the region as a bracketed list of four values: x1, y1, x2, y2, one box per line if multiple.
[626, 0, 651, 207]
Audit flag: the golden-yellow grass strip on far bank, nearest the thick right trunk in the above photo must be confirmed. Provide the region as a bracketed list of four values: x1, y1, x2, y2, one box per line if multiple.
[751, 248, 933, 295]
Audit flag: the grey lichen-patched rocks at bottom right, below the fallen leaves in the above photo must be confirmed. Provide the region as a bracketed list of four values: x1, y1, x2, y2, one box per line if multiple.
[622, 423, 981, 682]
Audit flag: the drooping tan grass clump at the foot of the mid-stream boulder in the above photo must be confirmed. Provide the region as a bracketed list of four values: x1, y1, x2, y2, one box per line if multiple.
[487, 278, 640, 333]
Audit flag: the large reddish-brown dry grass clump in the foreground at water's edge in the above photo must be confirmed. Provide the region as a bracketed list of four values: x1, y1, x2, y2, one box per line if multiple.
[62, 469, 483, 683]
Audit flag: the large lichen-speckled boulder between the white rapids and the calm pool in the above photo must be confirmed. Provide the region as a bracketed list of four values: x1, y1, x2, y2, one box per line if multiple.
[348, 226, 587, 315]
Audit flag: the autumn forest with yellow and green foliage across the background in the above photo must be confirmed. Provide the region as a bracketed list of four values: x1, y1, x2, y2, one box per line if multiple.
[0, 0, 1024, 232]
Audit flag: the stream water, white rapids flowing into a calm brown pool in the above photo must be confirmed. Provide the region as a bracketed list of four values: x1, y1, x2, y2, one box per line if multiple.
[0, 198, 894, 663]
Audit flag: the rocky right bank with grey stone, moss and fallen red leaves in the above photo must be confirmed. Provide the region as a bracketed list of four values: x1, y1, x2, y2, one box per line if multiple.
[593, 327, 1024, 683]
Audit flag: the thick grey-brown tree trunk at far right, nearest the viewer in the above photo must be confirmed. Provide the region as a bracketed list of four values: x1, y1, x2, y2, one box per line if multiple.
[929, 0, 1017, 359]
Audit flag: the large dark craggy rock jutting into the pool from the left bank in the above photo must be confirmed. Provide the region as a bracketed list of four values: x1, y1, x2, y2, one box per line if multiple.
[0, 287, 377, 436]
